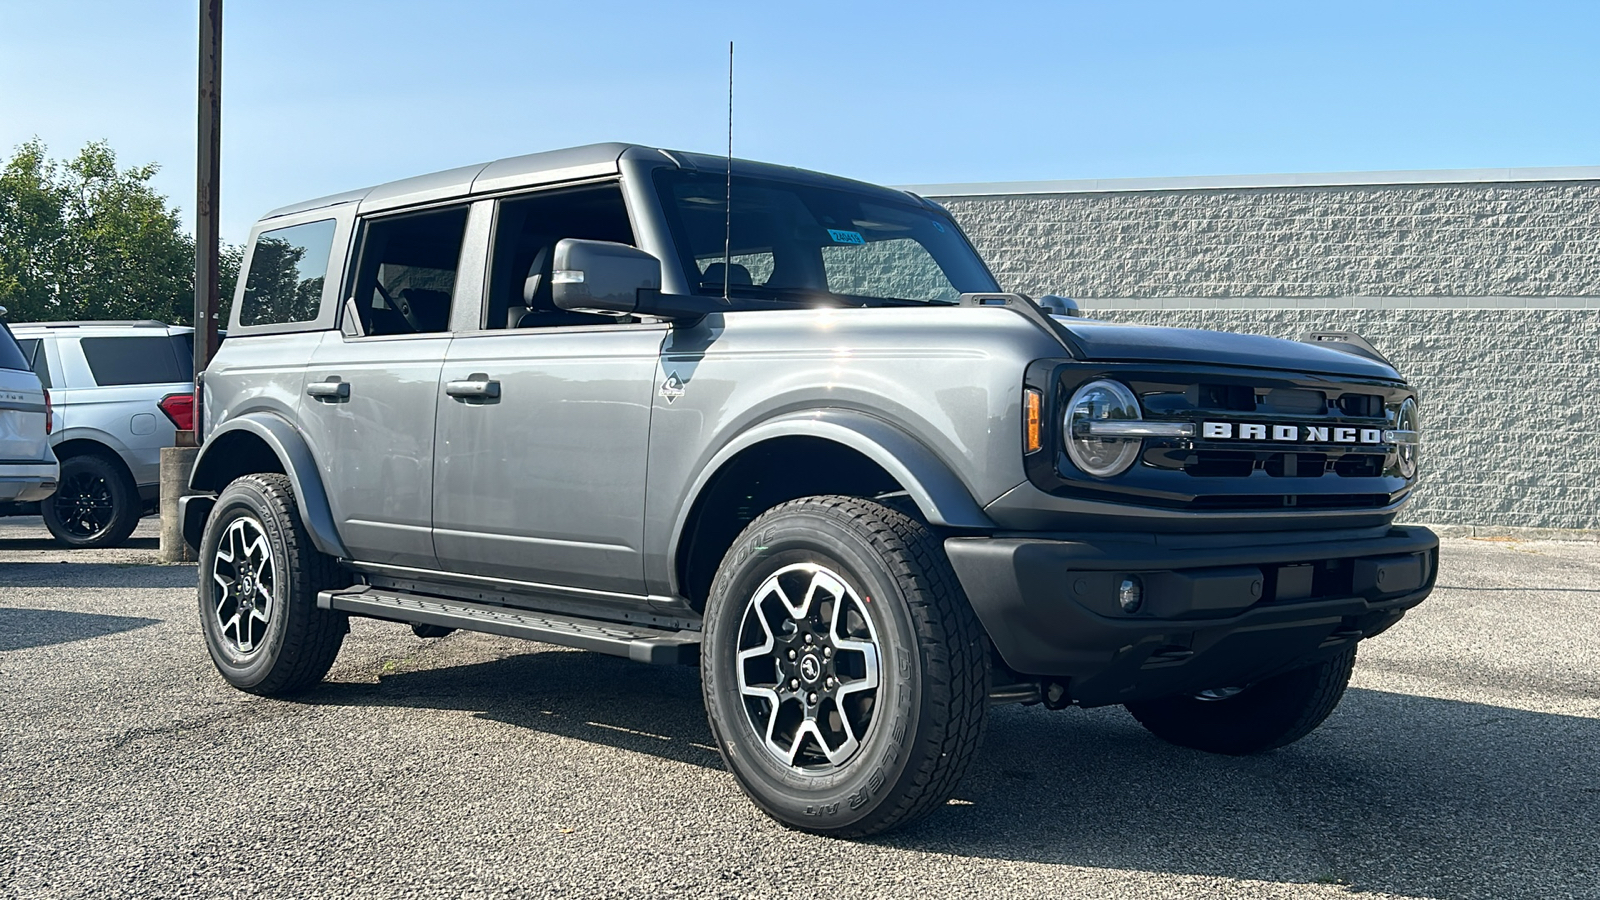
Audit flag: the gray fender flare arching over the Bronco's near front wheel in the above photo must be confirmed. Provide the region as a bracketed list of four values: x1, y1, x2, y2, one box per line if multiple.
[667, 408, 995, 589]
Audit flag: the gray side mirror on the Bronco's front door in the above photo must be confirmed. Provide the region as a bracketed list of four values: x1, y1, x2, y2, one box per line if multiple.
[550, 237, 722, 319]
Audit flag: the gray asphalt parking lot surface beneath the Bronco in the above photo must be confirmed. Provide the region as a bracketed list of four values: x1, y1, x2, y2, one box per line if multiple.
[0, 519, 1600, 900]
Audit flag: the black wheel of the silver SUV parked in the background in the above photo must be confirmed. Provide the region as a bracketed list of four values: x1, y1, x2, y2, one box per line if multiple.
[38, 453, 144, 549]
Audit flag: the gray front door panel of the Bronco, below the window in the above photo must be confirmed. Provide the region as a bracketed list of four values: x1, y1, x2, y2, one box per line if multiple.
[434, 325, 666, 605]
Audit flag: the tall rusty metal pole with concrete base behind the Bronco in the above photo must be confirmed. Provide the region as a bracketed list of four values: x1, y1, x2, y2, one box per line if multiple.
[160, 0, 222, 562]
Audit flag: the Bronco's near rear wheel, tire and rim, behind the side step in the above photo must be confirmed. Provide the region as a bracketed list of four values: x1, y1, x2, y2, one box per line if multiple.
[200, 474, 349, 697]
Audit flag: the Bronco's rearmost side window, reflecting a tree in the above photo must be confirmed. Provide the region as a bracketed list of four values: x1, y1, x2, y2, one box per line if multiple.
[238, 219, 334, 325]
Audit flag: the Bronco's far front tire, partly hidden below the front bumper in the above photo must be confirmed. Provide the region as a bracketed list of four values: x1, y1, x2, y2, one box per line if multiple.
[1128, 647, 1355, 756]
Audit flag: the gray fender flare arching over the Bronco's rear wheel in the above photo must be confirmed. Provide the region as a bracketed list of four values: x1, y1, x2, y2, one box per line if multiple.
[182, 412, 350, 559]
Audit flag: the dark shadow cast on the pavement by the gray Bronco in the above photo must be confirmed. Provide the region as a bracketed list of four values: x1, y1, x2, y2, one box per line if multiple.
[306, 650, 1600, 897]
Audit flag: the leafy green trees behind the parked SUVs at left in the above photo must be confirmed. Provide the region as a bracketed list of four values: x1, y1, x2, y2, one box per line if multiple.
[0, 139, 240, 325]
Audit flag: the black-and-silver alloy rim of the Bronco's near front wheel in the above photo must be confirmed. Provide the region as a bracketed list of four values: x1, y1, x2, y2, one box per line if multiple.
[738, 562, 882, 762]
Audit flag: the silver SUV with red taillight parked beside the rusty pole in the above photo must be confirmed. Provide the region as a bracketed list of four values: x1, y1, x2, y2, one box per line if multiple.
[13, 322, 194, 548]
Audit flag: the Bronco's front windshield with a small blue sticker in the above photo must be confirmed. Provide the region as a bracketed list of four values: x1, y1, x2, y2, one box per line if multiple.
[656, 168, 997, 306]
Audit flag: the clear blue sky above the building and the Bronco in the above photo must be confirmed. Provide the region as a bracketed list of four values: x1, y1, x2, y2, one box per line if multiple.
[0, 0, 1600, 240]
